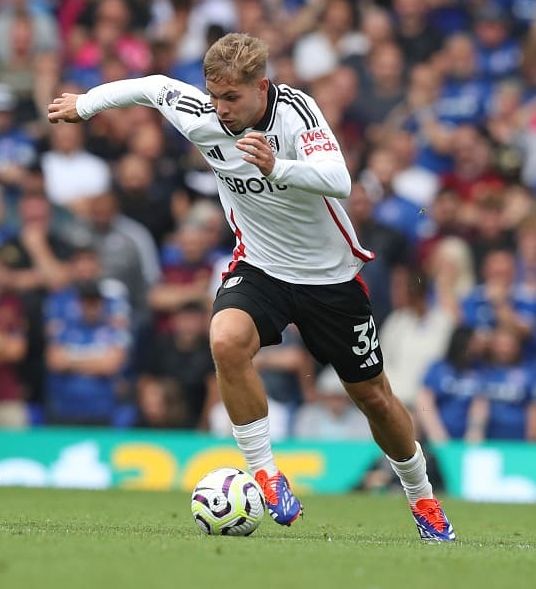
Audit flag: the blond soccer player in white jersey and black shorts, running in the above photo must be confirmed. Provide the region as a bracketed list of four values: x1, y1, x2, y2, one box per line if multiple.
[48, 33, 454, 541]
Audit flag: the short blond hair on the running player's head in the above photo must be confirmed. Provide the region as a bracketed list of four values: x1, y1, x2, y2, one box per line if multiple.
[203, 33, 268, 84]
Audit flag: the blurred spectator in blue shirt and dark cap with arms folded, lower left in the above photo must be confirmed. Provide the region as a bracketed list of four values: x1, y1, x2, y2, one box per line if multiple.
[45, 281, 129, 425]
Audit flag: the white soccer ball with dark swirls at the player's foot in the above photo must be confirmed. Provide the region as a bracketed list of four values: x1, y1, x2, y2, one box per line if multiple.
[192, 468, 265, 536]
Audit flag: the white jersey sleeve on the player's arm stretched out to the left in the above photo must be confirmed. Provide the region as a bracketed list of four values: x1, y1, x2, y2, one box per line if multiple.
[76, 75, 212, 139]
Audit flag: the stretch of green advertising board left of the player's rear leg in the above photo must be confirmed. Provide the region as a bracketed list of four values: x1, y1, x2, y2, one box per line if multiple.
[0, 428, 380, 493]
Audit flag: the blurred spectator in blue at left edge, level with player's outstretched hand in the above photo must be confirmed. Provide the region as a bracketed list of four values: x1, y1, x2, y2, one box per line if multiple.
[0, 84, 37, 200]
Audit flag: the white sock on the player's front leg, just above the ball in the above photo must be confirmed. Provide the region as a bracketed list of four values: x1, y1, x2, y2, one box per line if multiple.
[233, 417, 277, 477]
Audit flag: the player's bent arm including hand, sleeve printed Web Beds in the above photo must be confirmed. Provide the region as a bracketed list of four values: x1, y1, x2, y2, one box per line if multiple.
[236, 96, 352, 198]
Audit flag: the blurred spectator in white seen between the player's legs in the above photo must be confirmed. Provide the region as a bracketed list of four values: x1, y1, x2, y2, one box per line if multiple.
[294, 366, 372, 440]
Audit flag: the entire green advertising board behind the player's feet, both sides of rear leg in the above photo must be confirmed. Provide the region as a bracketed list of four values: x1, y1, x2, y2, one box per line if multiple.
[0, 428, 536, 503]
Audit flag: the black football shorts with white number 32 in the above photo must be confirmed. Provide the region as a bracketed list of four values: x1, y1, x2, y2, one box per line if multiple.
[213, 262, 383, 383]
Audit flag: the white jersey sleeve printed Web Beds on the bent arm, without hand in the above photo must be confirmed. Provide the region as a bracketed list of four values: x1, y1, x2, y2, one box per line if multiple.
[268, 87, 351, 198]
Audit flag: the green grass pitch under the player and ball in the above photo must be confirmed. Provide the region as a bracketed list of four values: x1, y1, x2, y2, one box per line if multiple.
[0, 489, 536, 589]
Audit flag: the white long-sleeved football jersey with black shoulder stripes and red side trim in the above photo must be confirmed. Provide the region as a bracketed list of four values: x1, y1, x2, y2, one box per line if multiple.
[77, 75, 374, 284]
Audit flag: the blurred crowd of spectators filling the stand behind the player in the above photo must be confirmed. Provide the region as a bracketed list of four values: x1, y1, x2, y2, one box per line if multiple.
[0, 0, 536, 450]
